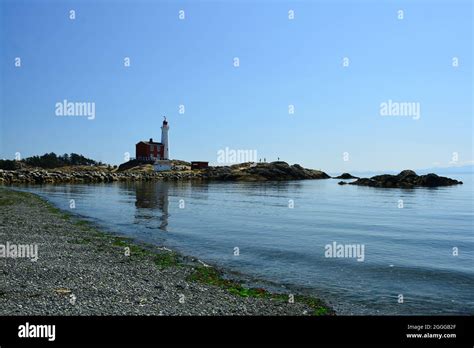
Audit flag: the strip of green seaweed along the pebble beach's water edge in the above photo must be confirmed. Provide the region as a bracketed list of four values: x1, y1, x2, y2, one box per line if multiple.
[0, 187, 335, 316]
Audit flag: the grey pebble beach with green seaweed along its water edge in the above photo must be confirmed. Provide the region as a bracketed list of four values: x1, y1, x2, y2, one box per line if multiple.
[0, 187, 335, 315]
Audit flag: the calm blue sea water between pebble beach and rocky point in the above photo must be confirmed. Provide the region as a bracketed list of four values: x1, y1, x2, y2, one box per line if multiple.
[20, 174, 474, 314]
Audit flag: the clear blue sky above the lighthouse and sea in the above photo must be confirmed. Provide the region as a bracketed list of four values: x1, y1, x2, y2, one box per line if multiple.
[0, 0, 474, 171]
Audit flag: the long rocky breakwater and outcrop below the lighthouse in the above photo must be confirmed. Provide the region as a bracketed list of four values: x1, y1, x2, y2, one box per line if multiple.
[0, 162, 329, 185]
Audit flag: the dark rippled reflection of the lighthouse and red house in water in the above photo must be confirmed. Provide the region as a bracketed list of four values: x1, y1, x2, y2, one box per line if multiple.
[135, 182, 169, 231]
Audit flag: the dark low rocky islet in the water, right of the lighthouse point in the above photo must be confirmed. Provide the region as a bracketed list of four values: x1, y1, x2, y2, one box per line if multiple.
[349, 170, 462, 188]
